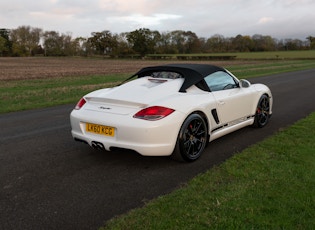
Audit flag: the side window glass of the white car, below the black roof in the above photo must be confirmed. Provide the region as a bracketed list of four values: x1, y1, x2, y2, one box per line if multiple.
[205, 71, 238, 92]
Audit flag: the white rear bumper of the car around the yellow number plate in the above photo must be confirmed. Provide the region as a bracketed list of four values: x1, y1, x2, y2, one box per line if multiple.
[70, 110, 185, 156]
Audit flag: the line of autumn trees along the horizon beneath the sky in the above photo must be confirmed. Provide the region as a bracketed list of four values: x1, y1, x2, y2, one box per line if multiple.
[0, 26, 315, 57]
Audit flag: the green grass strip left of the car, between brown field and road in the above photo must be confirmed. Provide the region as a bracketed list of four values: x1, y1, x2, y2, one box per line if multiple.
[0, 74, 129, 113]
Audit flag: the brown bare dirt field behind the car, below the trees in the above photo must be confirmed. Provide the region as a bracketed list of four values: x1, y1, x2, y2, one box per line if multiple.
[0, 57, 247, 80]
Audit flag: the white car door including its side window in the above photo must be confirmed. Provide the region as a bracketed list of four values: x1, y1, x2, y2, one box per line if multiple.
[205, 71, 253, 125]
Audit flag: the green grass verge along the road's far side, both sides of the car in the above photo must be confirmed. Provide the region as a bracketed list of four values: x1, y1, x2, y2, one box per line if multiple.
[0, 60, 315, 113]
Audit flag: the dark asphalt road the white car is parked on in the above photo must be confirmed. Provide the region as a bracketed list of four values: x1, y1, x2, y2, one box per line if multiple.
[0, 69, 315, 230]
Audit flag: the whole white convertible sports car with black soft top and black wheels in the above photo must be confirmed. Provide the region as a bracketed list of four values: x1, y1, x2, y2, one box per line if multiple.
[70, 64, 272, 161]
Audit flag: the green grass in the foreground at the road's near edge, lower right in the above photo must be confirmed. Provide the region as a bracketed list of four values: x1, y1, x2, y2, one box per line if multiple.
[101, 113, 315, 230]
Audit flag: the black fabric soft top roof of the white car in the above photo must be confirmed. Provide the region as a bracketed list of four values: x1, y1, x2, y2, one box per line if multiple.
[132, 64, 225, 92]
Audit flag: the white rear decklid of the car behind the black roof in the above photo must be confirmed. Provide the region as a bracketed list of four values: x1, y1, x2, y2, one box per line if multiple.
[84, 77, 183, 115]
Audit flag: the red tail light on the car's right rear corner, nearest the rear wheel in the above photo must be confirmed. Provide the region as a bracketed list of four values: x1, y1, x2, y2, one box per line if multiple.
[133, 106, 175, 121]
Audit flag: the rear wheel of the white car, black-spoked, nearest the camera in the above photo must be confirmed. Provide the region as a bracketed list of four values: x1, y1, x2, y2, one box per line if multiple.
[172, 114, 208, 162]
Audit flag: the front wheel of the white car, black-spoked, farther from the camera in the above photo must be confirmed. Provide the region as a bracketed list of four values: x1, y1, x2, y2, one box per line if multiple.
[253, 95, 270, 128]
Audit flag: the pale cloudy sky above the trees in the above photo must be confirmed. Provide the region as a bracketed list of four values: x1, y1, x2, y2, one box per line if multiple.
[0, 0, 315, 40]
